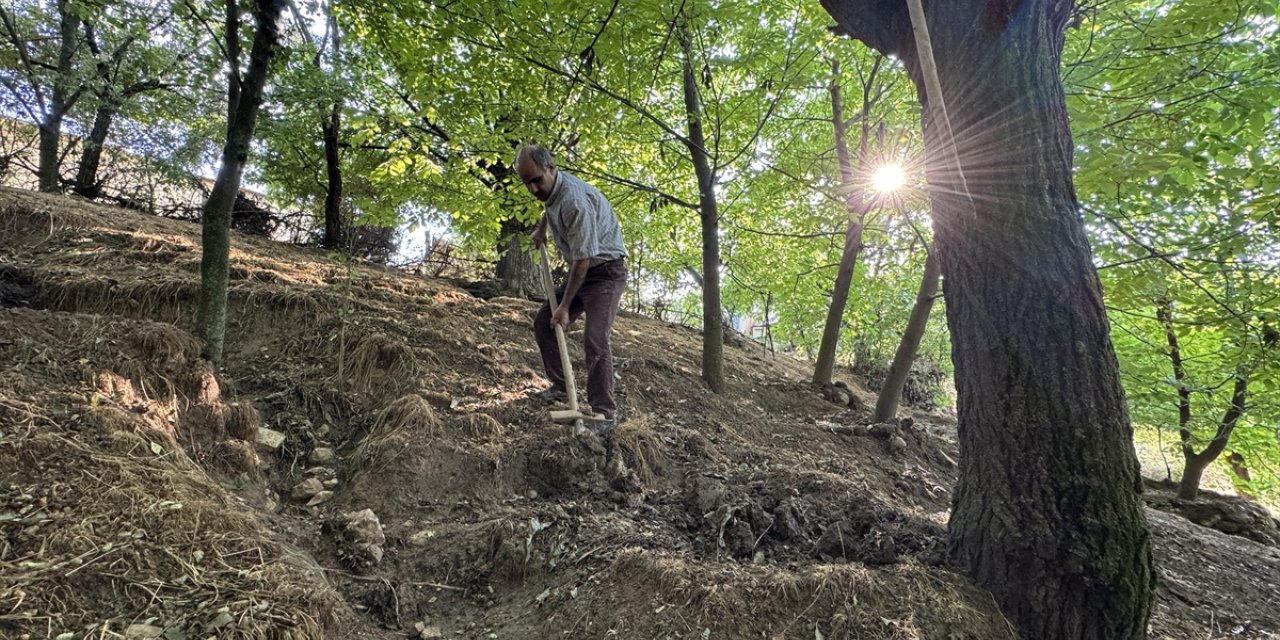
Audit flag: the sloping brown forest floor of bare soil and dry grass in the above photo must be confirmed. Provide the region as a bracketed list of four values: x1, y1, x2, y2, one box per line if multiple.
[0, 189, 1280, 640]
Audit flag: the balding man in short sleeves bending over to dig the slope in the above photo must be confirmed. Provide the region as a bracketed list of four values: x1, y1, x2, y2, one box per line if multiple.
[516, 146, 627, 434]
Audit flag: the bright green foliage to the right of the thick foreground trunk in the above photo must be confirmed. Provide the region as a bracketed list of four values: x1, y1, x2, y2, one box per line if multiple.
[1064, 0, 1280, 499]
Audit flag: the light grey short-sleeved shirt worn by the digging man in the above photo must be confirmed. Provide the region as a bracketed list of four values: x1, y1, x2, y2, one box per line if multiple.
[547, 170, 627, 266]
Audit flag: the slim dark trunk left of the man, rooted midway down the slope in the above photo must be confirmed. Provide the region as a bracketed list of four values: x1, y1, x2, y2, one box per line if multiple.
[198, 0, 284, 366]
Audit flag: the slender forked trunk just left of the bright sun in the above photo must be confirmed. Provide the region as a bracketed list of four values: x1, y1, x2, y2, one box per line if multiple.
[813, 61, 879, 384]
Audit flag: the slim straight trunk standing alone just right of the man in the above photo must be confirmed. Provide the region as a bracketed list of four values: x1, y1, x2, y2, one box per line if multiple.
[680, 17, 724, 393]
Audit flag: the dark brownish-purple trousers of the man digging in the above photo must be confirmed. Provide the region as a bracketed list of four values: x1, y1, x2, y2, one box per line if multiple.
[534, 259, 627, 417]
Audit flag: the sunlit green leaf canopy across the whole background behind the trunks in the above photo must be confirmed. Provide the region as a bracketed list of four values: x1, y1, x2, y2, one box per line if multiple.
[0, 0, 1280, 494]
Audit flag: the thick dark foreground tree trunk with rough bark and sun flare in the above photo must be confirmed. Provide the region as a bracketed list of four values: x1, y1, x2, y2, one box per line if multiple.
[822, 0, 1155, 640]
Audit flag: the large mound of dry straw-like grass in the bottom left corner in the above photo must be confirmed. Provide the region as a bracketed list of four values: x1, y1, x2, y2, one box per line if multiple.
[0, 391, 342, 640]
